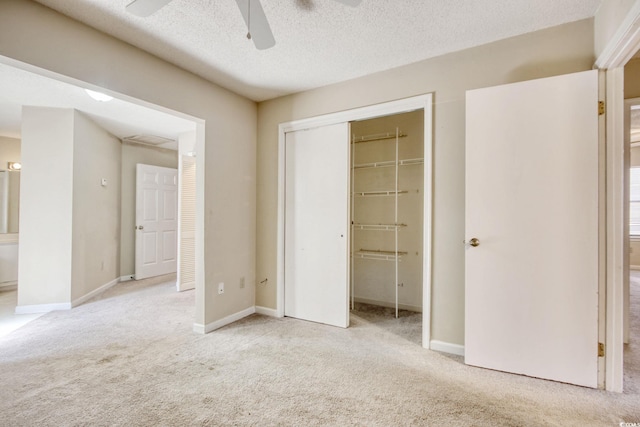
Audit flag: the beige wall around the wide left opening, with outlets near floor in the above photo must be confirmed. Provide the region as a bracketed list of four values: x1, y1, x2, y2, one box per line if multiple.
[0, 0, 257, 324]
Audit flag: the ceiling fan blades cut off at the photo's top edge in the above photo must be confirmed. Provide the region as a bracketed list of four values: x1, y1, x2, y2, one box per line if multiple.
[126, 0, 362, 50]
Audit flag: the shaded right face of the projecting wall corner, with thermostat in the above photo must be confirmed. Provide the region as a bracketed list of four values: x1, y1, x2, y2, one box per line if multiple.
[71, 111, 120, 301]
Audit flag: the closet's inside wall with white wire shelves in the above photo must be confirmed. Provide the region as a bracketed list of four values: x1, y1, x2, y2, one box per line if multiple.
[351, 110, 424, 312]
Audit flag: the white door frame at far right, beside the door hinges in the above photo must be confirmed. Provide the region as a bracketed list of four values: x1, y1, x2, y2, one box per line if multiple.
[595, 1, 640, 393]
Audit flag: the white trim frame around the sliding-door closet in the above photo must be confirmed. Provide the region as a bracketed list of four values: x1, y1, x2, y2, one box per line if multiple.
[276, 93, 433, 348]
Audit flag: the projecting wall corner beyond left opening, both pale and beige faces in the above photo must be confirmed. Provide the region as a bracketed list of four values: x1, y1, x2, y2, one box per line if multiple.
[18, 107, 120, 306]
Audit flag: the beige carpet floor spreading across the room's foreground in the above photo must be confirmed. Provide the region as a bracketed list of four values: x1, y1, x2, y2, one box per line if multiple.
[0, 274, 640, 426]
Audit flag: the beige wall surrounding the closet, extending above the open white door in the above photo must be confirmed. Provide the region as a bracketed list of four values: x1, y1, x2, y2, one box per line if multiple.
[256, 20, 594, 344]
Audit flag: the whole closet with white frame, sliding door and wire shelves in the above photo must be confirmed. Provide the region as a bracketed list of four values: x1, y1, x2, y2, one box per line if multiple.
[276, 94, 433, 349]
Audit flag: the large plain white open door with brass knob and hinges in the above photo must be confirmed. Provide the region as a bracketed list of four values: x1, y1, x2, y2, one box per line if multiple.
[465, 71, 599, 387]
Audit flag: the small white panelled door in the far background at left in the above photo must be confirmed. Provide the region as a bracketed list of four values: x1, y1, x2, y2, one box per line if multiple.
[135, 164, 178, 280]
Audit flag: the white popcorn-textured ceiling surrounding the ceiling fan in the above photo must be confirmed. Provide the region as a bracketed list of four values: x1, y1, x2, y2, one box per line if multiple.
[32, 0, 602, 101]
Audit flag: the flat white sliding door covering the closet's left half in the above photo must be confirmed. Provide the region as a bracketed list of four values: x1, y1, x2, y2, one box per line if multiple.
[284, 123, 349, 328]
